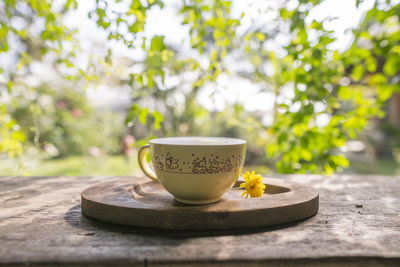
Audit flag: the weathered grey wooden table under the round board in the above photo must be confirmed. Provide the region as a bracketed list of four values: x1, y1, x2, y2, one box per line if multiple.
[0, 175, 400, 266]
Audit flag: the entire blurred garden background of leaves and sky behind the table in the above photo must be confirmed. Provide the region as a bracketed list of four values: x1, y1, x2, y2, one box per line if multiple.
[0, 0, 400, 176]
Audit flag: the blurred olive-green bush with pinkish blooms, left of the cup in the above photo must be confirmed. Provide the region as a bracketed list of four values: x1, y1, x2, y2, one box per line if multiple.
[11, 84, 123, 157]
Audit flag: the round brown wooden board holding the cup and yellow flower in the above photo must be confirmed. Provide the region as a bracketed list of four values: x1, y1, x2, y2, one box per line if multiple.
[81, 178, 319, 230]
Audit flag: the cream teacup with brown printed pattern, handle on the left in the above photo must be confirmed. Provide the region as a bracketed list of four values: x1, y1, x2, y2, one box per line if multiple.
[138, 137, 247, 204]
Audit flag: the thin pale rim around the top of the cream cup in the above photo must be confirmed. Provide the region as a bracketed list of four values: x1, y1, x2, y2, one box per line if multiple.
[149, 136, 247, 147]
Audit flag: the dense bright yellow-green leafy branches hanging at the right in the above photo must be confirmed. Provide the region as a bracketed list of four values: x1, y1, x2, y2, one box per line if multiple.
[256, 1, 400, 174]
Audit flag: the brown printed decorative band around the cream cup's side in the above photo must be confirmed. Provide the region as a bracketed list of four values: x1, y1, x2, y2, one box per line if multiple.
[153, 152, 243, 174]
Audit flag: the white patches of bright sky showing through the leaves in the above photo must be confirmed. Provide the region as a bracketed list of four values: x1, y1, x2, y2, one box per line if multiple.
[67, 0, 374, 124]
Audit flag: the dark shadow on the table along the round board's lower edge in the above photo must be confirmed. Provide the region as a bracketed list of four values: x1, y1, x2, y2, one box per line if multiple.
[64, 204, 310, 238]
